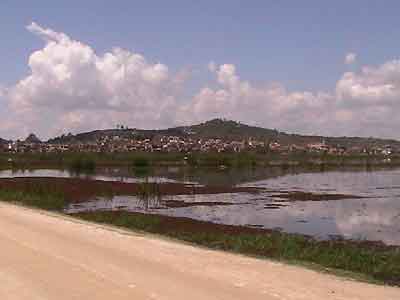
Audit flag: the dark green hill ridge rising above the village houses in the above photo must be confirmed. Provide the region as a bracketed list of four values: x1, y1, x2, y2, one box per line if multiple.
[48, 119, 400, 149]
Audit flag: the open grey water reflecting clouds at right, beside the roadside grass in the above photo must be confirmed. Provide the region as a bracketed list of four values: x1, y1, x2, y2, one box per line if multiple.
[65, 170, 400, 245]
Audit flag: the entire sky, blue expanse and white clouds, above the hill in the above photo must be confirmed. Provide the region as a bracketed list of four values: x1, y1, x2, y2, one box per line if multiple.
[0, 0, 400, 139]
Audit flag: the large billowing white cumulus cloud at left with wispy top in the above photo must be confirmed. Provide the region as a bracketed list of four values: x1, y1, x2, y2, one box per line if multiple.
[2, 23, 184, 136]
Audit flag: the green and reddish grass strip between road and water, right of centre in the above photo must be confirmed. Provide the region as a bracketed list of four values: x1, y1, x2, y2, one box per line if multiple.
[77, 212, 400, 285]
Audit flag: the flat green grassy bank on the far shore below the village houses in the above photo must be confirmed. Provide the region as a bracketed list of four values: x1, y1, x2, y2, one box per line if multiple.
[0, 152, 400, 171]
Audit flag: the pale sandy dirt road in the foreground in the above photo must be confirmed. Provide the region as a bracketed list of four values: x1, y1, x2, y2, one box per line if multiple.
[0, 204, 400, 300]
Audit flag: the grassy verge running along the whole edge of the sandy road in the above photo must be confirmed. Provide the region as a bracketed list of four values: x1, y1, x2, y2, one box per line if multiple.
[0, 192, 400, 286]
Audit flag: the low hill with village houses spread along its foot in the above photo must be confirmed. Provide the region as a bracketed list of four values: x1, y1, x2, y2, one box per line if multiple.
[0, 119, 400, 155]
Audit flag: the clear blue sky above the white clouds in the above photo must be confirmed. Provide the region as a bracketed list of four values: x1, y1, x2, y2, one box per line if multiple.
[0, 0, 400, 136]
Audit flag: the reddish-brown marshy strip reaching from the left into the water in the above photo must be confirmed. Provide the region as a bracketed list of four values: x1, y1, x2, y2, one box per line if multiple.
[0, 177, 362, 206]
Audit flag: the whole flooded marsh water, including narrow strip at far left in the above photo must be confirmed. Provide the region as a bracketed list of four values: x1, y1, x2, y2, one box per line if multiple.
[0, 168, 400, 245]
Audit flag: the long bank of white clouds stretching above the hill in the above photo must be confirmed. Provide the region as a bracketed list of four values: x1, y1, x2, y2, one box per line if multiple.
[0, 23, 400, 138]
